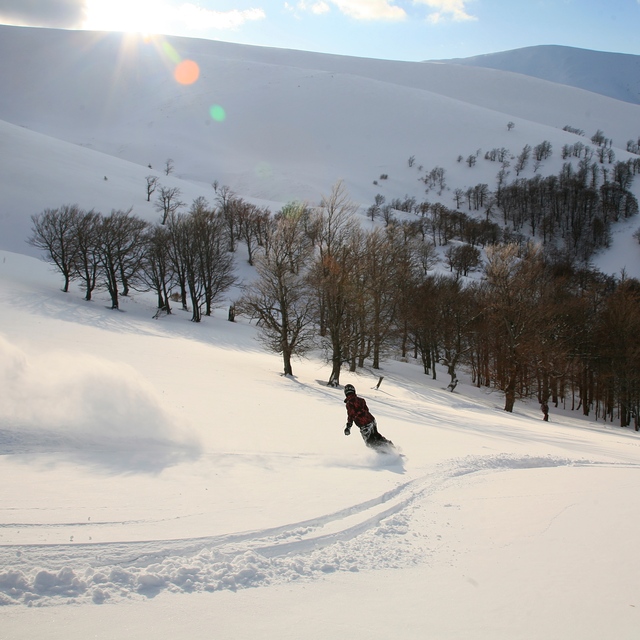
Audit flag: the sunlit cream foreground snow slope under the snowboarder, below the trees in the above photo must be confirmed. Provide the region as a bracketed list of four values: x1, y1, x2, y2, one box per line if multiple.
[0, 245, 640, 640]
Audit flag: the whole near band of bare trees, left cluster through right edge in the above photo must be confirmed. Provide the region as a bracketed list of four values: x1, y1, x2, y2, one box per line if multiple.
[29, 183, 640, 428]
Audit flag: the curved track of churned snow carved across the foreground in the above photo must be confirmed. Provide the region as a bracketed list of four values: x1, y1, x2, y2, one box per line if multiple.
[0, 455, 640, 606]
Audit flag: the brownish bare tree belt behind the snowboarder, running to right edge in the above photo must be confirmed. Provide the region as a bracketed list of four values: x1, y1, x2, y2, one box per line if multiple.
[234, 185, 640, 428]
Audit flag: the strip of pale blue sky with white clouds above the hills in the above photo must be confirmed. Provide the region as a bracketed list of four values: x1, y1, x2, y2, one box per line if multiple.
[0, 0, 640, 61]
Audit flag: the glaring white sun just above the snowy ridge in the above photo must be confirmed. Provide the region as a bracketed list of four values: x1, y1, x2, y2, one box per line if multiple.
[83, 0, 171, 35]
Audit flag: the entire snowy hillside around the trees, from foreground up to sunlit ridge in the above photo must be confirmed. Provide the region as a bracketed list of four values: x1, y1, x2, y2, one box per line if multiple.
[0, 27, 640, 640]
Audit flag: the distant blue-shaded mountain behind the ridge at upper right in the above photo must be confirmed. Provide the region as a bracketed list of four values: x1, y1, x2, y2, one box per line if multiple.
[438, 45, 640, 104]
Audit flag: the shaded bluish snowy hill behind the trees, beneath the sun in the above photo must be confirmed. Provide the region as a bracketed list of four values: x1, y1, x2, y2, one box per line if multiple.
[0, 27, 640, 272]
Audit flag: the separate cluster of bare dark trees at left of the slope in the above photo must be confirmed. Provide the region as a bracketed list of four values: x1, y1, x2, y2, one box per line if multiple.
[28, 198, 235, 322]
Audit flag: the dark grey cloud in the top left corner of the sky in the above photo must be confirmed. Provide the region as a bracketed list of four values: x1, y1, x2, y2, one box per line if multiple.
[0, 0, 86, 28]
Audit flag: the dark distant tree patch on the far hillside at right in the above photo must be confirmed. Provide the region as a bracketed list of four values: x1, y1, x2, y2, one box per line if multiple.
[368, 158, 640, 262]
